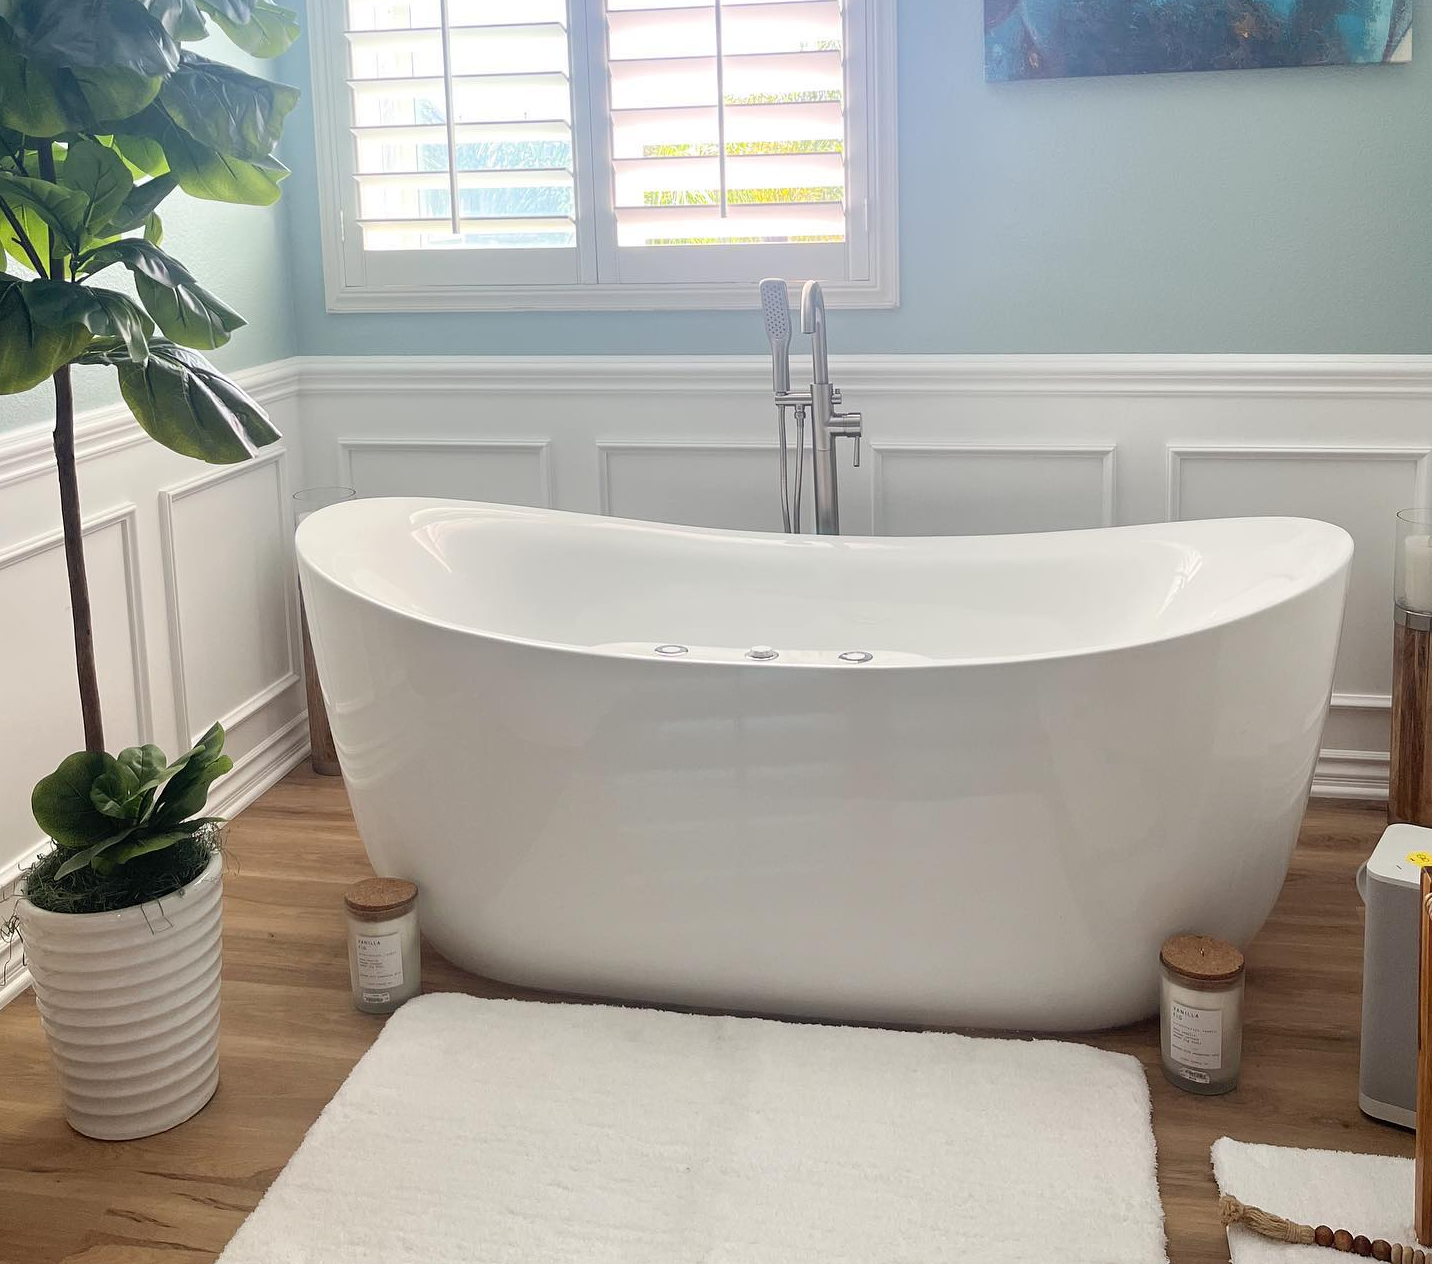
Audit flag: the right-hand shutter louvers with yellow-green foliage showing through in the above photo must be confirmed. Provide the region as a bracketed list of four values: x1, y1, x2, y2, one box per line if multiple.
[606, 0, 846, 248]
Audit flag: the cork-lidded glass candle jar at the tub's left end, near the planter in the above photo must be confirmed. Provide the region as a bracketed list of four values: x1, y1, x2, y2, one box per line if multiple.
[344, 877, 422, 1013]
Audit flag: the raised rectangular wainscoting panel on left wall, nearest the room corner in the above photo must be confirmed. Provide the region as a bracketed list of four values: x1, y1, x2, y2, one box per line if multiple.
[159, 449, 302, 746]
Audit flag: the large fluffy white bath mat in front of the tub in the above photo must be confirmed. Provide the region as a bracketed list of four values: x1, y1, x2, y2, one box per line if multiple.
[221, 995, 1166, 1264]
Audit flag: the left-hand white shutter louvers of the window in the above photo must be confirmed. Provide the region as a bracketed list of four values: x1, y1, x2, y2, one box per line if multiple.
[347, 0, 576, 251]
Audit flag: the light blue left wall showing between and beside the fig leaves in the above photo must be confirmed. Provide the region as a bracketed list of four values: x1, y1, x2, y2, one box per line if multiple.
[0, 36, 296, 431]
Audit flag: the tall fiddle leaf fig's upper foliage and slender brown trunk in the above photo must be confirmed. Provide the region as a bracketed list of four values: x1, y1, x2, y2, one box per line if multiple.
[0, 0, 298, 754]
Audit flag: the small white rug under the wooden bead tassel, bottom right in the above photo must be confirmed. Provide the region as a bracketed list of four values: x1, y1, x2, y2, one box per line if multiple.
[1213, 1137, 1416, 1264]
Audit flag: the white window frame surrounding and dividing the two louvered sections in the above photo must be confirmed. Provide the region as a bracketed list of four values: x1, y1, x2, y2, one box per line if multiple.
[308, 0, 899, 312]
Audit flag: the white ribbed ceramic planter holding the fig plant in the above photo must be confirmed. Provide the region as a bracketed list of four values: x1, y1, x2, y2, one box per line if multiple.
[17, 853, 223, 1141]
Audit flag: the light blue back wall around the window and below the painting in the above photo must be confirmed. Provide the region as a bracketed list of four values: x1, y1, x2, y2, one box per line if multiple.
[284, 0, 1432, 355]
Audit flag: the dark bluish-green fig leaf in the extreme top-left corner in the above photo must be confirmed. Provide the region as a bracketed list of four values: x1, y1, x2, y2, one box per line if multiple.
[10, 0, 179, 77]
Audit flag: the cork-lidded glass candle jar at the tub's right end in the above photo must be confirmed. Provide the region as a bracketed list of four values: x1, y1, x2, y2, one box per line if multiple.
[1158, 935, 1243, 1095]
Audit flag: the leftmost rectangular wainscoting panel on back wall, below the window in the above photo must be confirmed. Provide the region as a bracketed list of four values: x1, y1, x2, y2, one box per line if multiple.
[338, 438, 553, 508]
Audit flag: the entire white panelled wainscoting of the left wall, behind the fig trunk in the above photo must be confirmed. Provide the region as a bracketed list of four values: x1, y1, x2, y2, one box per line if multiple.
[0, 361, 308, 1005]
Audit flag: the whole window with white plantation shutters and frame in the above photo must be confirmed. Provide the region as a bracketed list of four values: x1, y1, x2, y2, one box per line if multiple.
[314, 0, 895, 311]
